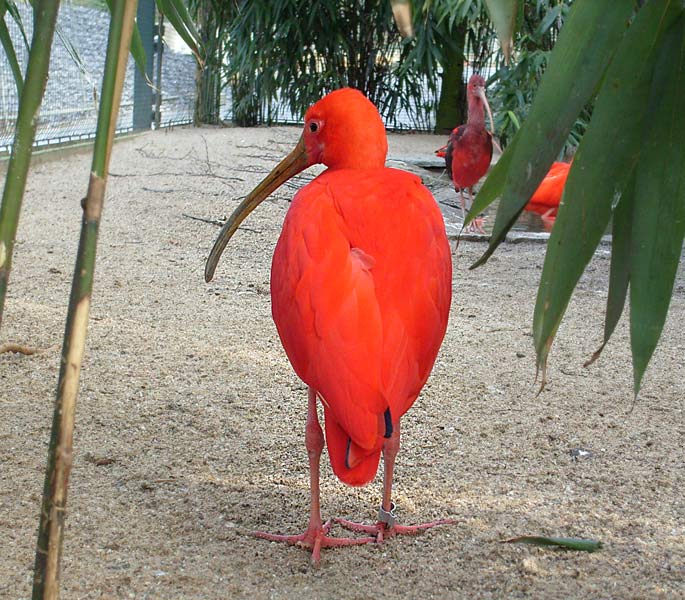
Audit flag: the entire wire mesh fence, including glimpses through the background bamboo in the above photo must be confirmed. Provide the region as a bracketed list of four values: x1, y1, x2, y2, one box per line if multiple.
[0, 0, 502, 152]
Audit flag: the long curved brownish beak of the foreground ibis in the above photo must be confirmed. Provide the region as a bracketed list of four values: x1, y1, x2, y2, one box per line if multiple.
[205, 138, 309, 283]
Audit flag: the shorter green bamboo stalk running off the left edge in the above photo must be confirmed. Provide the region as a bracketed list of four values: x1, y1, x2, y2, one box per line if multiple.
[0, 0, 59, 325]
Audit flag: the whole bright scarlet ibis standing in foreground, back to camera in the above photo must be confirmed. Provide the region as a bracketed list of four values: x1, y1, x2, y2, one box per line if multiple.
[205, 88, 452, 563]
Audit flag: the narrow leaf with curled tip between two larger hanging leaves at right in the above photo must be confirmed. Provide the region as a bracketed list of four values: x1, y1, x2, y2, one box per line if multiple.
[583, 170, 635, 367]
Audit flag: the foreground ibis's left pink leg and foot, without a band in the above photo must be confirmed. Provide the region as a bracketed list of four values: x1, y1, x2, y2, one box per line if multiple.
[254, 388, 375, 564]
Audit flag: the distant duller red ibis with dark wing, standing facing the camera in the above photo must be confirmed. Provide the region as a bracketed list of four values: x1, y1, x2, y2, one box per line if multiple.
[444, 75, 494, 233]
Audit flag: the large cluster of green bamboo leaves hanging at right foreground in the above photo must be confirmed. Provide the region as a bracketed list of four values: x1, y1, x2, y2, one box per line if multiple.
[473, 0, 685, 393]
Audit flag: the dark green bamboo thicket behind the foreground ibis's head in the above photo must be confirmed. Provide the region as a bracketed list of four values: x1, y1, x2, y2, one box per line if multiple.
[227, 0, 481, 128]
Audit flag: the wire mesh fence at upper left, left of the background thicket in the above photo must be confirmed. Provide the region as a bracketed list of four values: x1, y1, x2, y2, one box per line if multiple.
[0, 1, 195, 152]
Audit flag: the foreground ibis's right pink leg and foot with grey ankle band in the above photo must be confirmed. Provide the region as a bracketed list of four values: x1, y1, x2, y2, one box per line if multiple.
[335, 423, 457, 544]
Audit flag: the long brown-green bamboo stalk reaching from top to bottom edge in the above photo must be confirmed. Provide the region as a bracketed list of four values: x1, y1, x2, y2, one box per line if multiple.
[33, 0, 137, 600]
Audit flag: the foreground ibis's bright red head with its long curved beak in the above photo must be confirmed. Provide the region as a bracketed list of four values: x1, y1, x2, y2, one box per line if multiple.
[205, 88, 388, 281]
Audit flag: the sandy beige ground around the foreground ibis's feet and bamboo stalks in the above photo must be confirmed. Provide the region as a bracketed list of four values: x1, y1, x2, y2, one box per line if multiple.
[0, 128, 685, 599]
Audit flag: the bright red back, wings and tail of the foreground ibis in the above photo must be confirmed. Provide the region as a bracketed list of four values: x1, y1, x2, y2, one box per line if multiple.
[271, 169, 452, 485]
